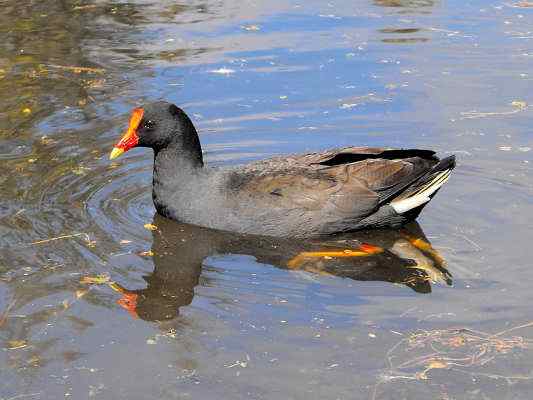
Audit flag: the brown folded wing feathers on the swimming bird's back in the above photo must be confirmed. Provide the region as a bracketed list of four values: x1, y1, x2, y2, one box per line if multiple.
[230, 147, 436, 219]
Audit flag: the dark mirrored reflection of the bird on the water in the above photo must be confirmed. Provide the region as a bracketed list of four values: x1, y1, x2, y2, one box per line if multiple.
[115, 214, 451, 321]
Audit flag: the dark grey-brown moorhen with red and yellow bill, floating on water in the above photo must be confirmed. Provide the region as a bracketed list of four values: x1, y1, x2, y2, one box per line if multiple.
[110, 102, 455, 238]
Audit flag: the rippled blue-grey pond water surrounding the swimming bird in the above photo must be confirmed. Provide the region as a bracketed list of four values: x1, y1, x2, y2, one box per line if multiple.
[0, 0, 533, 399]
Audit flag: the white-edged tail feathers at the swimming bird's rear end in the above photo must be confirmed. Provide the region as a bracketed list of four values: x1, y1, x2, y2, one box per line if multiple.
[390, 155, 455, 214]
